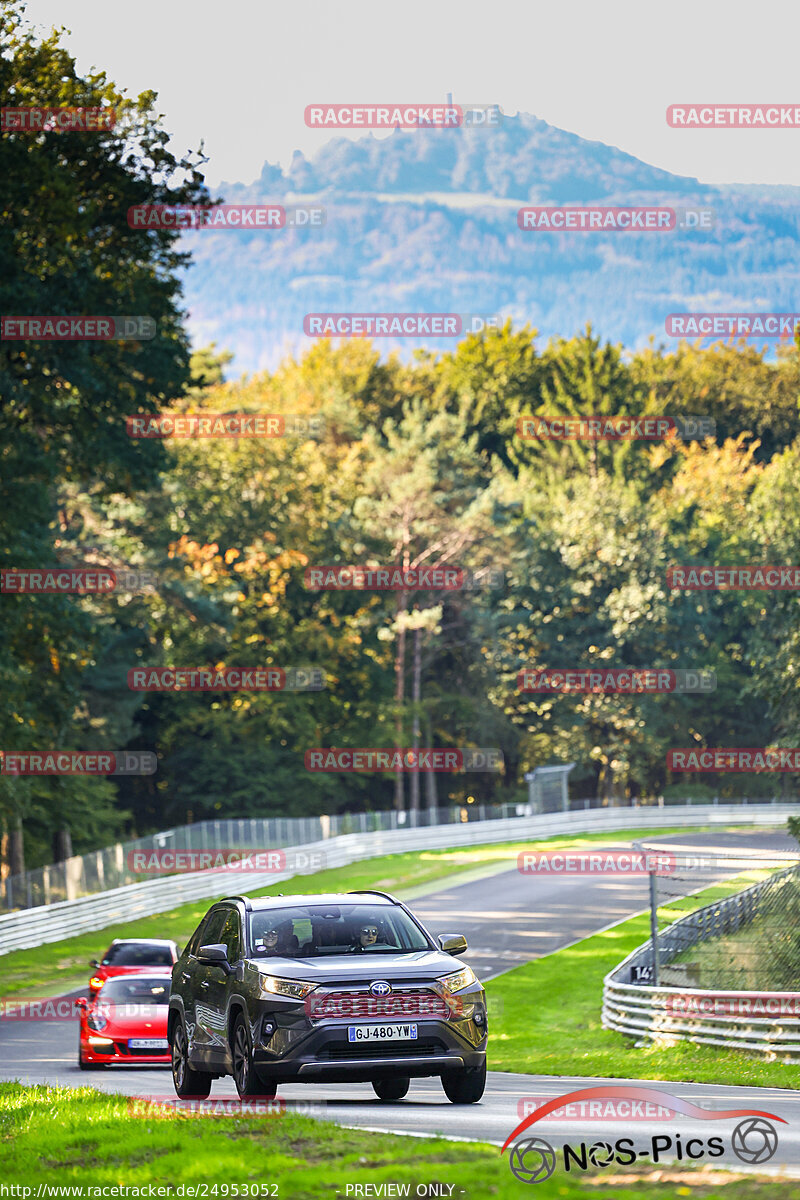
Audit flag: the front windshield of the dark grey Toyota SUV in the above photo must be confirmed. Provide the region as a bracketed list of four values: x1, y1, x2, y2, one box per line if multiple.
[249, 902, 431, 959]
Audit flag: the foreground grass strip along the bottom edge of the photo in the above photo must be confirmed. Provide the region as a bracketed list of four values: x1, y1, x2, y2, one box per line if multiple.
[0, 1084, 800, 1200]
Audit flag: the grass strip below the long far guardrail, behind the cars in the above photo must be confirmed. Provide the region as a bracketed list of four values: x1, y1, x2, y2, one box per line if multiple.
[0, 829, 698, 1000]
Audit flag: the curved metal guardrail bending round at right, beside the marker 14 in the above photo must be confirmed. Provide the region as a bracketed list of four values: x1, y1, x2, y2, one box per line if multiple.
[602, 866, 800, 1062]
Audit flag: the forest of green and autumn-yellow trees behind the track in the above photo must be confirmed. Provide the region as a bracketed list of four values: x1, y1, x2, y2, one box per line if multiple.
[0, 4, 800, 870]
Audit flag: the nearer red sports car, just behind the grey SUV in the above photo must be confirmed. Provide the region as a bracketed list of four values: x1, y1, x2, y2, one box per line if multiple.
[78, 971, 172, 1070]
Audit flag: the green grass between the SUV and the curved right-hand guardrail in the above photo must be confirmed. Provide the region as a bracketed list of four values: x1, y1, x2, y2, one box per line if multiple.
[486, 871, 800, 1088]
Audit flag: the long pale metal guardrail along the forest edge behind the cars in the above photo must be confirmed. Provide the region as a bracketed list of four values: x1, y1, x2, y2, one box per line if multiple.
[0, 804, 798, 955]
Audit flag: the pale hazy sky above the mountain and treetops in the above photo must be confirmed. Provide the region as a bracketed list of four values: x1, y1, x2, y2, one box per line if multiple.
[21, 0, 800, 187]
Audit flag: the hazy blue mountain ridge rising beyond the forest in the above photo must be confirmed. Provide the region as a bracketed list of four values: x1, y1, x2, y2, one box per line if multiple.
[185, 114, 800, 376]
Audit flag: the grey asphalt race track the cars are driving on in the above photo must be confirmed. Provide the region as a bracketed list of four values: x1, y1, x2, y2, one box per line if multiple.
[0, 829, 800, 1170]
